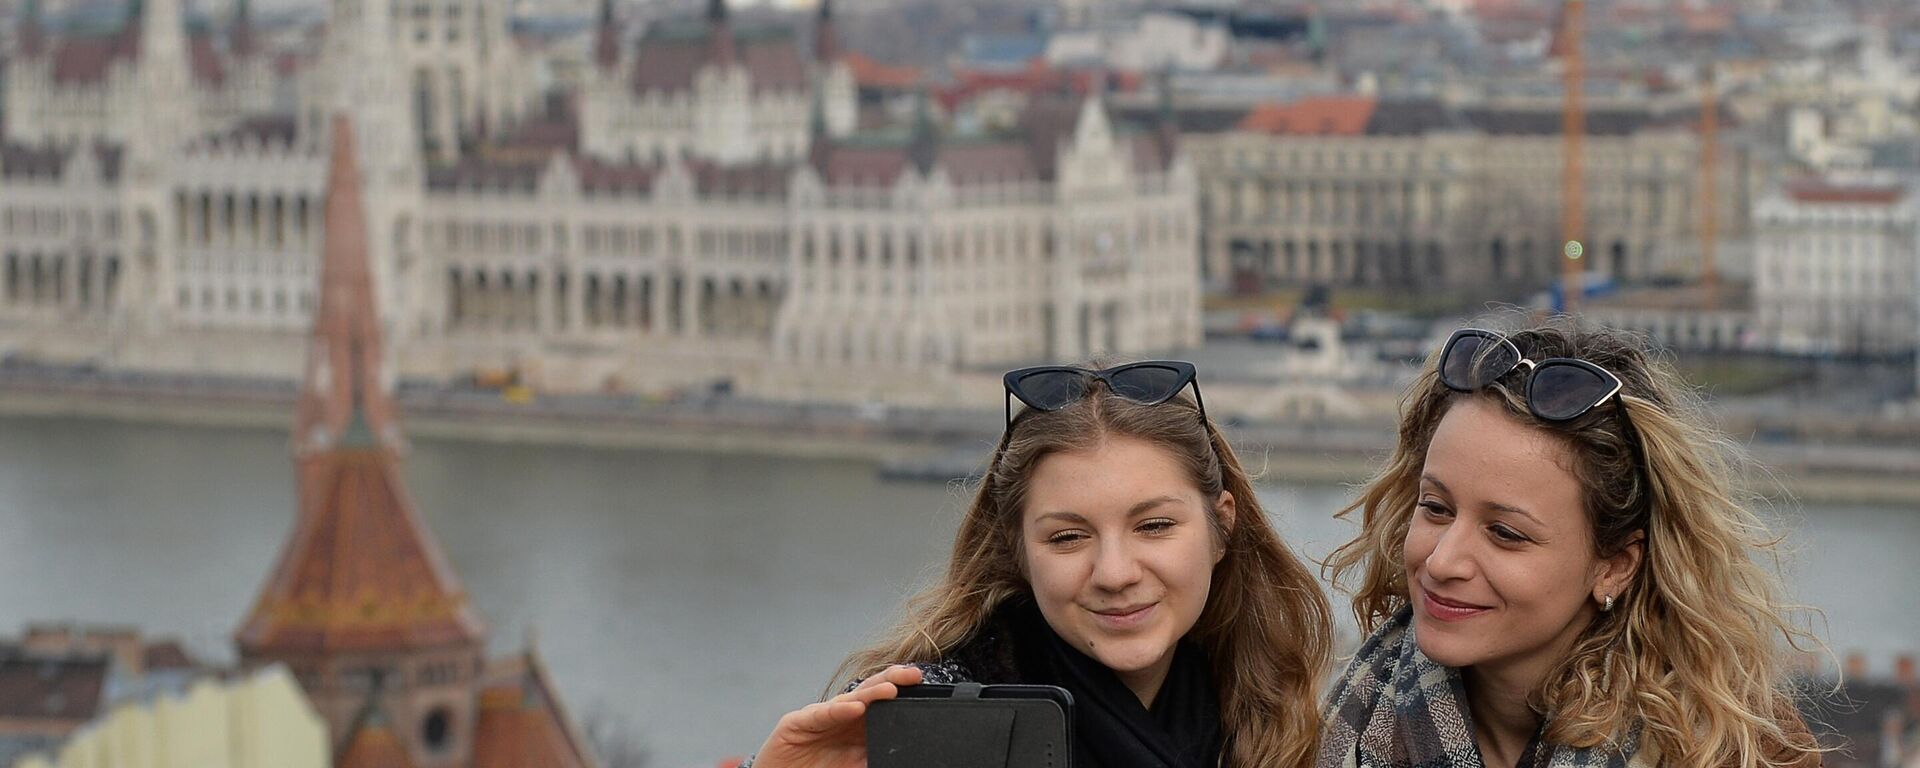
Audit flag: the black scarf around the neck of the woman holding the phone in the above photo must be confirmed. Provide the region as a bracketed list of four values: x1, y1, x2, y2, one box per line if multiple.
[954, 599, 1223, 768]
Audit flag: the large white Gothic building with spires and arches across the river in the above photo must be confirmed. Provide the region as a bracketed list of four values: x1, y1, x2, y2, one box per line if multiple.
[0, 0, 1200, 407]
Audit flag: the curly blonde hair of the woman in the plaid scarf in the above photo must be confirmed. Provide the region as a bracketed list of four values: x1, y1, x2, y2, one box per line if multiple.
[1323, 321, 1824, 768]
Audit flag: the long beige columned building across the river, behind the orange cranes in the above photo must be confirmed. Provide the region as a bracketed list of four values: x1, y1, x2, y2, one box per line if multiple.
[1187, 96, 1749, 292]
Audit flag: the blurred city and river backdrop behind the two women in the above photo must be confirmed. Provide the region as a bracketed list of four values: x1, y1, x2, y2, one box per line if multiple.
[0, 0, 1920, 768]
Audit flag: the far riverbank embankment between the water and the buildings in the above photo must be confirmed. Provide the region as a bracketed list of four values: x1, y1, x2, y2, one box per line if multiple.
[0, 382, 1920, 505]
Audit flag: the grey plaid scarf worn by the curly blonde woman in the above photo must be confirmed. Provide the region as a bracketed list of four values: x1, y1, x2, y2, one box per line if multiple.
[1317, 609, 1659, 768]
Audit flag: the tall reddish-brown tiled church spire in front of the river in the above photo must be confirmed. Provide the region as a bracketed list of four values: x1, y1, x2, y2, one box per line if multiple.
[236, 115, 484, 660]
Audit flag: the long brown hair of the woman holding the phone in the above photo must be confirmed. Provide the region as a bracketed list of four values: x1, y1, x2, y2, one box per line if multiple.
[835, 374, 1332, 768]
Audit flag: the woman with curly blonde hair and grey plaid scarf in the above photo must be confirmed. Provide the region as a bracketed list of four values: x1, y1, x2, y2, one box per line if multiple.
[1319, 324, 1820, 768]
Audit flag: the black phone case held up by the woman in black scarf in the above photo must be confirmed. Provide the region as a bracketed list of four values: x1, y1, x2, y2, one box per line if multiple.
[866, 684, 1073, 768]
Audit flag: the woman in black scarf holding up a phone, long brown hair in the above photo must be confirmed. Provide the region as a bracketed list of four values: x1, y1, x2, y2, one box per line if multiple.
[755, 361, 1331, 768]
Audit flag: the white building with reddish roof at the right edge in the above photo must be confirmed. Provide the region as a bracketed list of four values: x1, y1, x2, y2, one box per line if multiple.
[1753, 179, 1920, 355]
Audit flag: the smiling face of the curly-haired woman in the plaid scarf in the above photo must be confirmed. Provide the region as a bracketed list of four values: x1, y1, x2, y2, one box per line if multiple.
[1404, 397, 1640, 680]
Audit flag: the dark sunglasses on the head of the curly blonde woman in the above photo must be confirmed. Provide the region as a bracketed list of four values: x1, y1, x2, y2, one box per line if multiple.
[1440, 328, 1622, 420]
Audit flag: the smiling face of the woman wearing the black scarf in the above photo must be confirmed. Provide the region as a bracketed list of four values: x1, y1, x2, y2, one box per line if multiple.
[1020, 436, 1233, 703]
